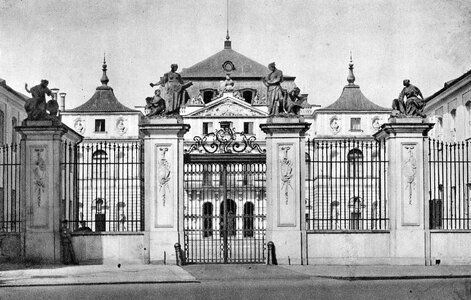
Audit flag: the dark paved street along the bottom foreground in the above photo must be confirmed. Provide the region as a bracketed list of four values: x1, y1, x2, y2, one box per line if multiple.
[0, 279, 471, 300]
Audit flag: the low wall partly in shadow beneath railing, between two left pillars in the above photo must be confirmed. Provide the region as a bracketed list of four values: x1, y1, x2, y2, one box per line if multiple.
[72, 232, 145, 264]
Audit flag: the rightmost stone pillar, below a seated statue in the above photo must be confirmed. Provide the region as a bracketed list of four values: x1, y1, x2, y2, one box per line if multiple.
[374, 117, 433, 265]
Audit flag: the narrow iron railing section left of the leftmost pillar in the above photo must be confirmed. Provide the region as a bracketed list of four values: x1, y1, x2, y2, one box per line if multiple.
[0, 144, 22, 232]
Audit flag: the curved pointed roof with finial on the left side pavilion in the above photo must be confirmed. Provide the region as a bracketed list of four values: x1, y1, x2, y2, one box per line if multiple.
[67, 61, 139, 113]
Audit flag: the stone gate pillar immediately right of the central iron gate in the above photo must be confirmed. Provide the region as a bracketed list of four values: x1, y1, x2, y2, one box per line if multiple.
[260, 117, 311, 264]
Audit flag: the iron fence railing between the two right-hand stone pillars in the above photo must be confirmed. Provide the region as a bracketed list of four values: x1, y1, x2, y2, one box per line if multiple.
[305, 139, 389, 231]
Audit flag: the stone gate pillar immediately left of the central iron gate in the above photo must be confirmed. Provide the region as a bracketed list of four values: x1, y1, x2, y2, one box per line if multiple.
[140, 118, 190, 263]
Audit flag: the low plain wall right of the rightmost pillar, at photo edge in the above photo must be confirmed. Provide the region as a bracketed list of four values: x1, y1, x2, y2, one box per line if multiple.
[430, 232, 471, 265]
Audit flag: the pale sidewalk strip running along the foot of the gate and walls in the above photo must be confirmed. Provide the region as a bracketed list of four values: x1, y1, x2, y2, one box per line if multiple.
[0, 264, 471, 288]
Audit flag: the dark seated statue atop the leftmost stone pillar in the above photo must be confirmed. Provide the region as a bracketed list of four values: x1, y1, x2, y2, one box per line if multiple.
[25, 79, 59, 121]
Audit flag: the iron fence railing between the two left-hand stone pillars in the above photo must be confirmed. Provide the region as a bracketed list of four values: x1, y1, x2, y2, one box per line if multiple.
[62, 141, 144, 232]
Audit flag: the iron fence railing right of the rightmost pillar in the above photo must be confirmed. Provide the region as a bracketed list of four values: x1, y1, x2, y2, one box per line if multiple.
[426, 139, 471, 230]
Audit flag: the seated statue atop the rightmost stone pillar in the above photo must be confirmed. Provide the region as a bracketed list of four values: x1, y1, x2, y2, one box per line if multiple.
[393, 79, 425, 118]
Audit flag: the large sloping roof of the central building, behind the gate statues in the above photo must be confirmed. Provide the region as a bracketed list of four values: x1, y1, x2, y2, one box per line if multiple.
[180, 40, 295, 80]
